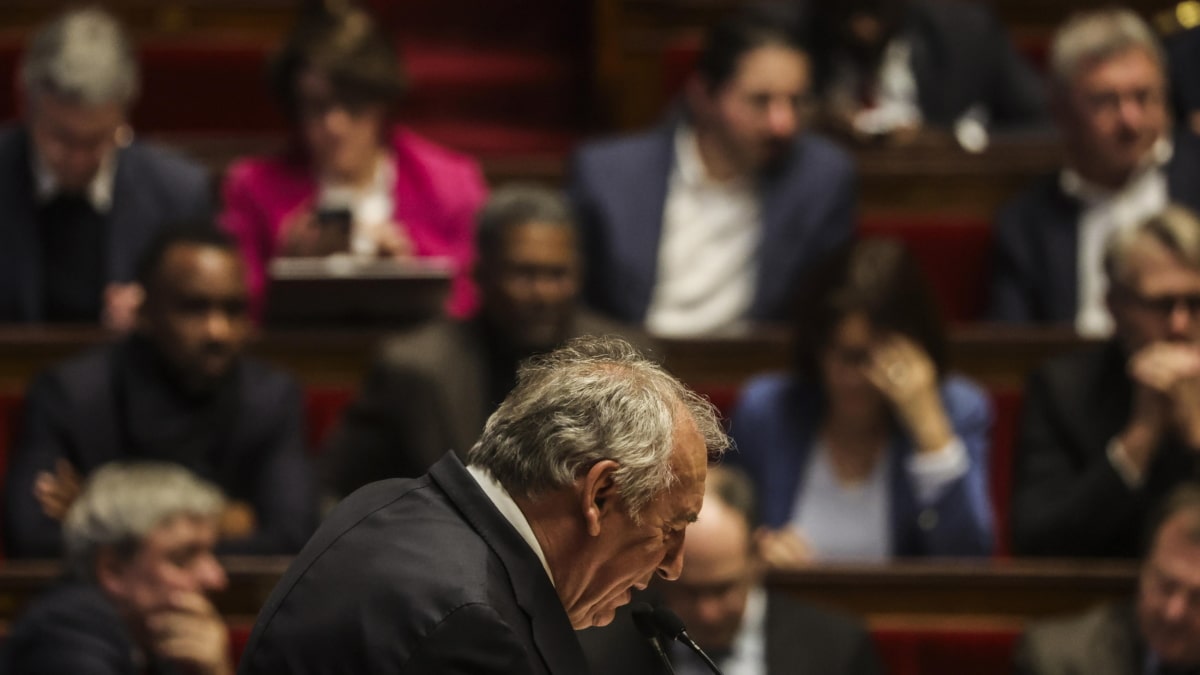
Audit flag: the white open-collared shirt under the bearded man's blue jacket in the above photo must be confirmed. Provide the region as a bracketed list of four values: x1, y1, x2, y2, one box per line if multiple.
[646, 125, 762, 336]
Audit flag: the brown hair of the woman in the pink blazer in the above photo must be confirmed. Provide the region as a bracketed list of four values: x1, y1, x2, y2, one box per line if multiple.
[269, 1, 408, 120]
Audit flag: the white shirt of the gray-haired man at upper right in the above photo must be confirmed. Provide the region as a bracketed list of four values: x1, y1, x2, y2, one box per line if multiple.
[1058, 138, 1174, 338]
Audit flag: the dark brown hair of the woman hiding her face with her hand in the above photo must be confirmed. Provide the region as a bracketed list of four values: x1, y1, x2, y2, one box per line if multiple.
[794, 239, 947, 382]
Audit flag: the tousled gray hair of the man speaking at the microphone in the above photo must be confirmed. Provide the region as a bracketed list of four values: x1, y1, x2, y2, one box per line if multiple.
[467, 338, 730, 519]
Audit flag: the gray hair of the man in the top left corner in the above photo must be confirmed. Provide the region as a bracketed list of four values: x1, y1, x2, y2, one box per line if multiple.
[20, 7, 138, 106]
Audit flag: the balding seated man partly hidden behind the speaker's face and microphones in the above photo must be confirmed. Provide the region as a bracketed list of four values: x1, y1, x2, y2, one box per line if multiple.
[578, 466, 883, 675]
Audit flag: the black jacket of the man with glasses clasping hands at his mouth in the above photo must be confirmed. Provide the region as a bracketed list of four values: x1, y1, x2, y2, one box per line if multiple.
[1012, 341, 1200, 558]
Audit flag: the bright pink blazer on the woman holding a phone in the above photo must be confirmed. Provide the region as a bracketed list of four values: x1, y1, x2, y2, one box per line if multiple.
[221, 127, 487, 317]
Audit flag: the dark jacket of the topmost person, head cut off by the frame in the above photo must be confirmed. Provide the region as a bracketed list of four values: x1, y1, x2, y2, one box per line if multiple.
[809, 0, 1049, 130]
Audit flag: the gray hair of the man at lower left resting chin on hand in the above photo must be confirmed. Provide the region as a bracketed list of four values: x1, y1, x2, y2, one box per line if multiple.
[62, 462, 224, 579]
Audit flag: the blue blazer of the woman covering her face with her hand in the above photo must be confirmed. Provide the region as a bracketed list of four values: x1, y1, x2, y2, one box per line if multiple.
[725, 374, 995, 557]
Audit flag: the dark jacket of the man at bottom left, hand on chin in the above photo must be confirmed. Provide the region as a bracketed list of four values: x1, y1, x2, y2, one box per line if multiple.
[0, 584, 176, 675]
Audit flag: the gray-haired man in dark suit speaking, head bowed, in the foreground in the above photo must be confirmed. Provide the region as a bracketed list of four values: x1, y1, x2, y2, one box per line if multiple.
[241, 338, 727, 675]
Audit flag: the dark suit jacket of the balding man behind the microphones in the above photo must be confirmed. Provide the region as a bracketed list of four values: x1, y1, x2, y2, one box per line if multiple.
[580, 592, 883, 675]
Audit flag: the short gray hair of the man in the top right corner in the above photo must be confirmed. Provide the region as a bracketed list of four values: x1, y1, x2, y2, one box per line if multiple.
[1050, 8, 1166, 88]
